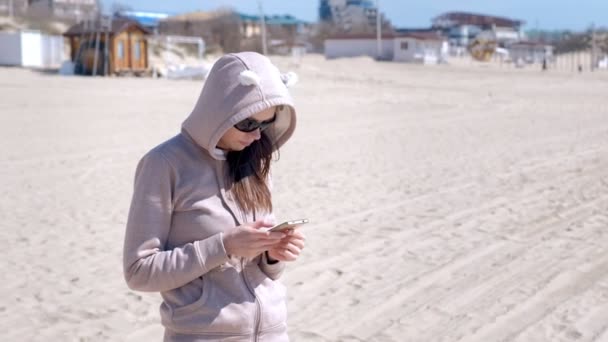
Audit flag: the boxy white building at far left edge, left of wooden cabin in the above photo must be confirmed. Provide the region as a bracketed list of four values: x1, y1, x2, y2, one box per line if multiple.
[0, 31, 64, 68]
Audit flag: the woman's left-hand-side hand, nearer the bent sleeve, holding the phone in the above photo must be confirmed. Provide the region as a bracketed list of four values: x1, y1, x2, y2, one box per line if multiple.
[224, 220, 287, 258]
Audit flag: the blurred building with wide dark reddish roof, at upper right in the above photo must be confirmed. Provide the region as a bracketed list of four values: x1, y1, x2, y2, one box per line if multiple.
[432, 12, 525, 47]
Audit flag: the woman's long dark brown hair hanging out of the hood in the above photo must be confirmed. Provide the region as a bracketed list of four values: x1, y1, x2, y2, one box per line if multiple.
[226, 132, 273, 215]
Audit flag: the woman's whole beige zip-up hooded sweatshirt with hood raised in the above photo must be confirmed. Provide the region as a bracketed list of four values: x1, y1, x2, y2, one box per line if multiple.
[123, 52, 296, 342]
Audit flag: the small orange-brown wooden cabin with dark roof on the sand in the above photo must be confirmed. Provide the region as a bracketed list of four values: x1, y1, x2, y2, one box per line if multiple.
[63, 18, 150, 75]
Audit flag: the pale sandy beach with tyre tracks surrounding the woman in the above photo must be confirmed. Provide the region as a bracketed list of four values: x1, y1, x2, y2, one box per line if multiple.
[0, 55, 608, 342]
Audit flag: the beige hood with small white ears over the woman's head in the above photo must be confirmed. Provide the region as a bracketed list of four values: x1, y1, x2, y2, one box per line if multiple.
[182, 52, 296, 160]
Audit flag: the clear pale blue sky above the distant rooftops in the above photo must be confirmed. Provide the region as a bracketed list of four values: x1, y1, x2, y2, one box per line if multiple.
[102, 0, 608, 30]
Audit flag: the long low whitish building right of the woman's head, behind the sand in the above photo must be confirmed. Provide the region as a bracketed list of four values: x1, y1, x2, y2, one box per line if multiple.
[324, 33, 447, 64]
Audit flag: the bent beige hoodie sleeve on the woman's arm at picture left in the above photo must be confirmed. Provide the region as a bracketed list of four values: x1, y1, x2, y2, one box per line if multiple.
[123, 151, 228, 292]
